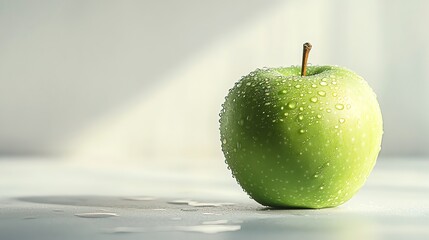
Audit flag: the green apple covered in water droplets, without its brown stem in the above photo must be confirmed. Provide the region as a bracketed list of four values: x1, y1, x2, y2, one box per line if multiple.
[220, 66, 383, 208]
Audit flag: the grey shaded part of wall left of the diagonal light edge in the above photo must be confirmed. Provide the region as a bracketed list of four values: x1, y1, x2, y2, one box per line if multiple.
[0, 0, 279, 154]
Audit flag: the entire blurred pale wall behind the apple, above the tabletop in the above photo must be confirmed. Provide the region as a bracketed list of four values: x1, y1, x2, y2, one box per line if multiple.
[0, 0, 429, 159]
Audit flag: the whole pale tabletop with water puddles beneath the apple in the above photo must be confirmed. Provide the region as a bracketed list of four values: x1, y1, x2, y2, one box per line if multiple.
[0, 158, 429, 240]
